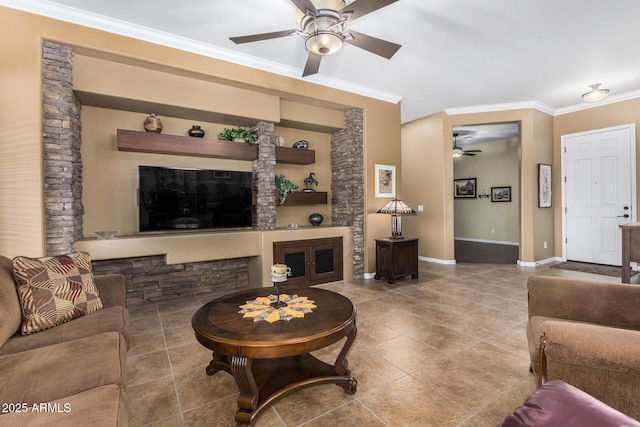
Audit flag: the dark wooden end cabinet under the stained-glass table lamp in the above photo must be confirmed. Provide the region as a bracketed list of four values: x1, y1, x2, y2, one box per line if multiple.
[375, 238, 418, 283]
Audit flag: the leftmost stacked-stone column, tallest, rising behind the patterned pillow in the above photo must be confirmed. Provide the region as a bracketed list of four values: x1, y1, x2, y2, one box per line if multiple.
[42, 41, 84, 255]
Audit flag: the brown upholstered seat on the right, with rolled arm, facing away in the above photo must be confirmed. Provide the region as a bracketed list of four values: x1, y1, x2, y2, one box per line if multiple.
[527, 276, 640, 419]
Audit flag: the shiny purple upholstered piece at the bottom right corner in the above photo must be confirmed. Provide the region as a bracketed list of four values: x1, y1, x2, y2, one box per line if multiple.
[496, 380, 640, 427]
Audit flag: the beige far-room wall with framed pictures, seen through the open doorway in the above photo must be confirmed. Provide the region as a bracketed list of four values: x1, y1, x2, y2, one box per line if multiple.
[453, 138, 520, 244]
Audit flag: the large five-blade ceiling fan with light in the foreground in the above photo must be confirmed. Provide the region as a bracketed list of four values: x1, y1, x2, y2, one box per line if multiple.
[229, 0, 401, 77]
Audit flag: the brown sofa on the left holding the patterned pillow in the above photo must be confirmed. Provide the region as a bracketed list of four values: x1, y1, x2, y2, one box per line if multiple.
[0, 256, 130, 426]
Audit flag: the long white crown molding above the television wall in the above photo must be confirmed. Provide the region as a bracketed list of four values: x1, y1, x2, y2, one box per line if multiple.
[0, 0, 402, 104]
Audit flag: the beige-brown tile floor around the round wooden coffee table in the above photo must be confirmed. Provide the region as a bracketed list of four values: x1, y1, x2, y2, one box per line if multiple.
[127, 262, 620, 427]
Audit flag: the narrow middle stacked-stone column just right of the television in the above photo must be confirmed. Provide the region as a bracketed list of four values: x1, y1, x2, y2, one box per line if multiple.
[253, 122, 276, 231]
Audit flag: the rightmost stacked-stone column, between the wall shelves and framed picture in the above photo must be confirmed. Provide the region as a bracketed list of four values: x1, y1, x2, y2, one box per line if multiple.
[331, 109, 364, 277]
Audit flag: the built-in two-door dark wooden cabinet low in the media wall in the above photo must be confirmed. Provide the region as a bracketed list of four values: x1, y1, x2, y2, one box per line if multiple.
[273, 237, 342, 289]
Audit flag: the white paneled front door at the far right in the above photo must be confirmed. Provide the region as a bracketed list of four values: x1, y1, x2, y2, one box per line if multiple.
[562, 124, 636, 265]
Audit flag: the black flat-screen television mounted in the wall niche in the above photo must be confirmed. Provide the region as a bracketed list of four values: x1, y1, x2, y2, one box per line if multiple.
[138, 166, 253, 232]
